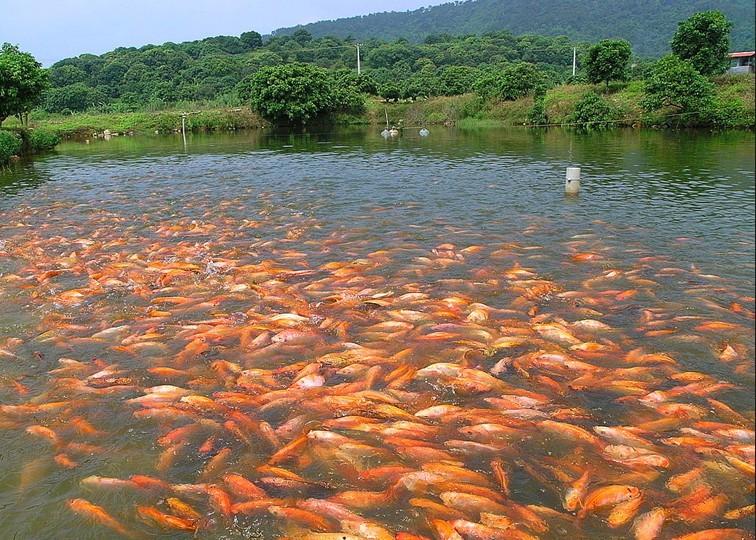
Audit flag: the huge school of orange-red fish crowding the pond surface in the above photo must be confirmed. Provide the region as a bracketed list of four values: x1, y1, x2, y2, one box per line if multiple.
[0, 199, 754, 540]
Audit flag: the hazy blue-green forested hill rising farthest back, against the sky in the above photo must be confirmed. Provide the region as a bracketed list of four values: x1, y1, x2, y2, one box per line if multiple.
[275, 0, 755, 56]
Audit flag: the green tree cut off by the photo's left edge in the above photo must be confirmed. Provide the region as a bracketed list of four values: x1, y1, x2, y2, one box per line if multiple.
[0, 43, 48, 124]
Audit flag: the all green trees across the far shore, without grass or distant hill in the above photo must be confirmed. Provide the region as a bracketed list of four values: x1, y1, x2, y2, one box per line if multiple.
[0, 11, 744, 129]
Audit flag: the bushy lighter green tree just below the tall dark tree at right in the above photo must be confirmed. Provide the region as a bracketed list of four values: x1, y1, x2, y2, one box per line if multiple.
[643, 54, 714, 114]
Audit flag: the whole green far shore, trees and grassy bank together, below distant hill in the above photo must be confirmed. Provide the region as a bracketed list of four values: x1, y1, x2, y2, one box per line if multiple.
[0, 11, 756, 163]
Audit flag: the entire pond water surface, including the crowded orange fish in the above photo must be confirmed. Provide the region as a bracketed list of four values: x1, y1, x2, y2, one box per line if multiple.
[0, 128, 754, 540]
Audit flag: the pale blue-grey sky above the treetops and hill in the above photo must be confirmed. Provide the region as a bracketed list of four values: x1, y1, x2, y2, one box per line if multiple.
[0, 0, 448, 65]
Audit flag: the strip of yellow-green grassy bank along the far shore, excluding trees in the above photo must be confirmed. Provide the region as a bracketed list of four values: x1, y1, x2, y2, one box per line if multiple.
[5, 76, 755, 138]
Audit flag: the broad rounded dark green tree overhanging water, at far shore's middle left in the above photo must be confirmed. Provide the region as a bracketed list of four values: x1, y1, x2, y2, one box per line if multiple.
[243, 64, 363, 124]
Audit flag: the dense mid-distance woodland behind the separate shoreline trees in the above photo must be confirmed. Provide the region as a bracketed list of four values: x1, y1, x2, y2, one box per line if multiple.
[32, 31, 587, 112]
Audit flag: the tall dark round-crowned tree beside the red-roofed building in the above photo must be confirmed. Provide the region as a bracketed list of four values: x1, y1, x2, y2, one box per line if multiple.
[672, 11, 732, 75]
